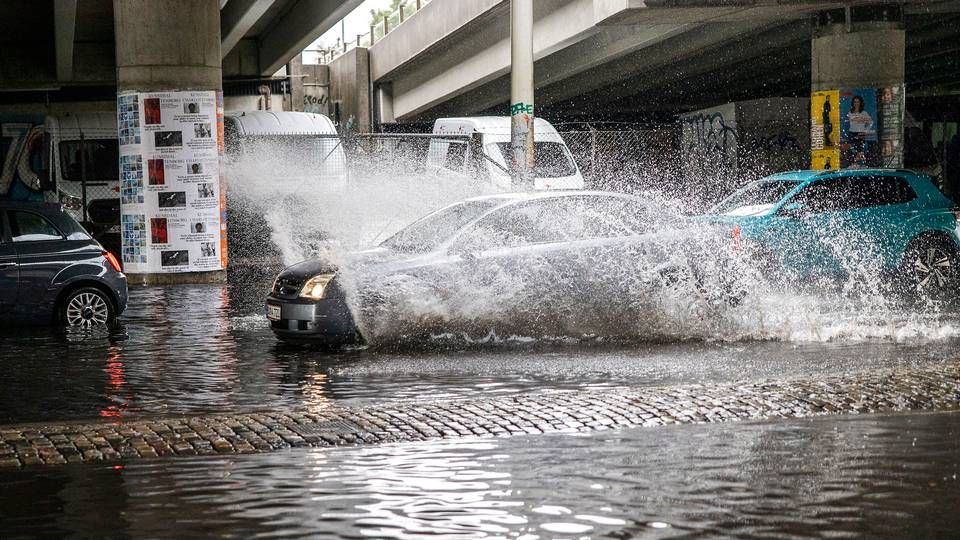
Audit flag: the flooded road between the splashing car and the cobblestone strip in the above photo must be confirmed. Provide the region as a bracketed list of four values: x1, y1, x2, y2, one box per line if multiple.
[0, 274, 960, 424]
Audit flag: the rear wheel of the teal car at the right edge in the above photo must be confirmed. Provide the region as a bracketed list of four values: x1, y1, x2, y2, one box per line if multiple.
[900, 238, 960, 300]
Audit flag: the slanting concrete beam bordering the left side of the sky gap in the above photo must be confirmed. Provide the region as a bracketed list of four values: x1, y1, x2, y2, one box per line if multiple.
[256, 0, 363, 76]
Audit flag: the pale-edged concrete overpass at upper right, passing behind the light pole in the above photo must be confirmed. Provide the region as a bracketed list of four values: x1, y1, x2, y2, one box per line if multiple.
[350, 0, 960, 122]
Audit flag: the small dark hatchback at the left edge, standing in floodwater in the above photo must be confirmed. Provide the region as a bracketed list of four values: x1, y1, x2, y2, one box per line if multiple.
[0, 201, 127, 327]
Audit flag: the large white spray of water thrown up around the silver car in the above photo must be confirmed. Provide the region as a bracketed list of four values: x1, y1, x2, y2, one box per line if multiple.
[228, 135, 960, 344]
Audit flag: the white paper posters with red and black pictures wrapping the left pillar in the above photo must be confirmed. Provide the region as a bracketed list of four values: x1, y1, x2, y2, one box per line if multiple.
[117, 91, 226, 273]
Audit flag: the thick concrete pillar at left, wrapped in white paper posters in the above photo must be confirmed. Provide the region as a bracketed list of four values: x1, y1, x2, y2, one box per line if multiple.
[113, 0, 227, 284]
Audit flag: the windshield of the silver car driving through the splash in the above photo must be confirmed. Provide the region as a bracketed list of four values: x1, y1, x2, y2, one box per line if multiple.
[380, 199, 503, 253]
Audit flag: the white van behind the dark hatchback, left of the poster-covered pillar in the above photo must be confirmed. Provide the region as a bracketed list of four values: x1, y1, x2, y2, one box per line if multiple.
[44, 112, 120, 222]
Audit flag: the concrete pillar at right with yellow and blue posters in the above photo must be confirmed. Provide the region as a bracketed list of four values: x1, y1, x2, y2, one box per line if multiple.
[810, 20, 905, 169]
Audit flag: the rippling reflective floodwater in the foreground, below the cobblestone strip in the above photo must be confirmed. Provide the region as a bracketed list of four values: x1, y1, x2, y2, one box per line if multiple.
[0, 413, 960, 538]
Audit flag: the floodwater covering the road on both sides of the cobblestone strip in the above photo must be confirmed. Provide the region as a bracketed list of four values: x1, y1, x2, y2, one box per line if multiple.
[0, 277, 960, 538]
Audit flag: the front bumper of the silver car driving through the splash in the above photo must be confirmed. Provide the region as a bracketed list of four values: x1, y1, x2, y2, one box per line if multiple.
[266, 295, 359, 344]
